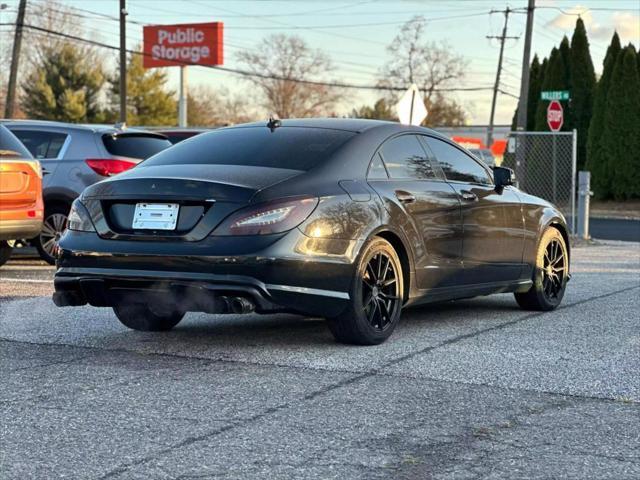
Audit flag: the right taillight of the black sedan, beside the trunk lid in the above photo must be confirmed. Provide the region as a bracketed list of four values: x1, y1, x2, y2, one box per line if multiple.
[212, 197, 318, 236]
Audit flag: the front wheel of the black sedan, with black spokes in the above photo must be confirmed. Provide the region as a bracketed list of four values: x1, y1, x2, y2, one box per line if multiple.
[514, 227, 569, 311]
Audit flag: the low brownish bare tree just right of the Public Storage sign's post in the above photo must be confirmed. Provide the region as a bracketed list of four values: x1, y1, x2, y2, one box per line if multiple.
[187, 85, 258, 127]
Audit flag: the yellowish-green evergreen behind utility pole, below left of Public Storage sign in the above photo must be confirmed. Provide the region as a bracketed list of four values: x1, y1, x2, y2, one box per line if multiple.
[111, 49, 178, 126]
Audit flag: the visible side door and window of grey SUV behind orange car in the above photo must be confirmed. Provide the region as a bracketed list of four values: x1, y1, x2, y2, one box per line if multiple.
[8, 125, 70, 188]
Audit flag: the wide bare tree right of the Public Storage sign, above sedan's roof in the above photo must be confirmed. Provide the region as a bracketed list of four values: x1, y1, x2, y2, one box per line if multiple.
[238, 34, 342, 118]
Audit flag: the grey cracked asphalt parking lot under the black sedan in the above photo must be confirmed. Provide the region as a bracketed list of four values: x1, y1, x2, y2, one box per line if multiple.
[0, 242, 640, 479]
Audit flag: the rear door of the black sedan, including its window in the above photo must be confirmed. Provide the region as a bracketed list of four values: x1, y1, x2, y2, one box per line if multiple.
[368, 135, 463, 289]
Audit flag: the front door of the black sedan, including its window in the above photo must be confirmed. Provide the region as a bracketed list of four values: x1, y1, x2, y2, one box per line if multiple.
[425, 137, 524, 284]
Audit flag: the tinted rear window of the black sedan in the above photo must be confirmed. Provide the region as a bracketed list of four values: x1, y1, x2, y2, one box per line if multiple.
[141, 127, 356, 171]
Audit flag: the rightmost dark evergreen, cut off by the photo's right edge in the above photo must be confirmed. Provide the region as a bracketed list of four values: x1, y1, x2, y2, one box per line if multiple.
[601, 44, 640, 200]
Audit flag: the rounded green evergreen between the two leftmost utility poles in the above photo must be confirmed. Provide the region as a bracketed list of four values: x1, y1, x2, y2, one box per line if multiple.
[21, 42, 105, 122]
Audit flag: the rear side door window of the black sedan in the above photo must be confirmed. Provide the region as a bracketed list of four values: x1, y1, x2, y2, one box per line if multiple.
[382, 135, 436, 180]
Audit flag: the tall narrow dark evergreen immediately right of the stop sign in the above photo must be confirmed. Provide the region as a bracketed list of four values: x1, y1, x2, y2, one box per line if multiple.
[568, 18, 596, 170]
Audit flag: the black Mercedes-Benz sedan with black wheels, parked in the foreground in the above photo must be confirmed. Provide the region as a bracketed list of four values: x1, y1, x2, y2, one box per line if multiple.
[53, 119, 569, 344]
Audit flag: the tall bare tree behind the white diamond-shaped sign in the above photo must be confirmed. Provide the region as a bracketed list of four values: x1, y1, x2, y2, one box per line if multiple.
[379, 16, 467, 125]
